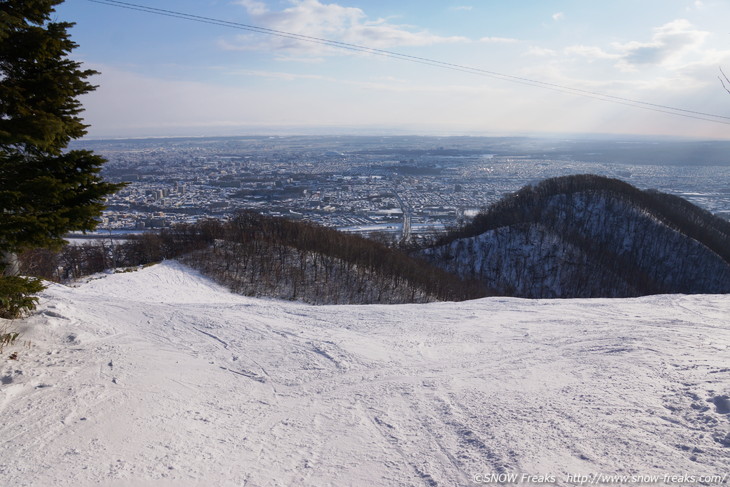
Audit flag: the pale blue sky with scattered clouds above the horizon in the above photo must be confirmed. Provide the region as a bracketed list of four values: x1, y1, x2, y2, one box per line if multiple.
[53, 0, 730, 139]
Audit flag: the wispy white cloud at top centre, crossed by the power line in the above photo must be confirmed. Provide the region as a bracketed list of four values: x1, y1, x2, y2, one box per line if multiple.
[228, 0, 469, 55]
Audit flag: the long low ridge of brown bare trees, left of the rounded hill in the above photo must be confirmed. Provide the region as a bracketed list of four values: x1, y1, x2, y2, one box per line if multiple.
[22, 212, 488, 304]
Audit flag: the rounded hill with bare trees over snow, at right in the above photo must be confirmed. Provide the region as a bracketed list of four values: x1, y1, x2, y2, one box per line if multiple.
[419, 175, 730, 298]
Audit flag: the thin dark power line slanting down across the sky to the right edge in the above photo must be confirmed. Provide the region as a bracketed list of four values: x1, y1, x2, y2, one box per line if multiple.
[88, 0, 730, 125]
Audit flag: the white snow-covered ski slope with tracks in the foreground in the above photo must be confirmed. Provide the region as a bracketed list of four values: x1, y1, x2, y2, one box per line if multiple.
[0, 262, 730, 486]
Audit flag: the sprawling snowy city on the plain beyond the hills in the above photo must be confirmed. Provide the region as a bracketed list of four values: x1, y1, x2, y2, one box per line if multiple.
[73, 136, 730, 238]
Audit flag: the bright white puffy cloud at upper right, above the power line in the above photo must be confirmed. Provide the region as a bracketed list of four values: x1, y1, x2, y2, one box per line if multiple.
[613, 19, 709, 71]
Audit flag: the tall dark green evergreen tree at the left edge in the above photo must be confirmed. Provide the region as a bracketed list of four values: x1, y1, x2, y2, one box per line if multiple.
[0, 0, 120, 315]
